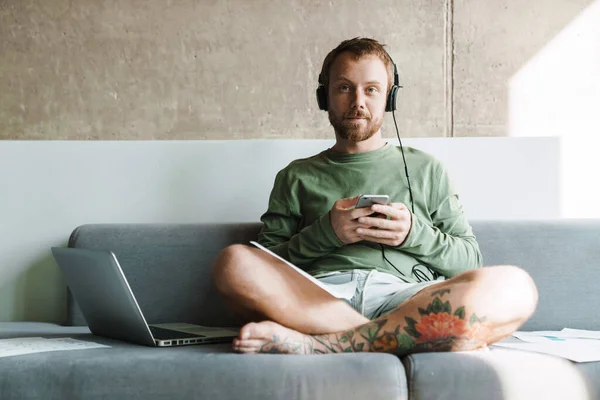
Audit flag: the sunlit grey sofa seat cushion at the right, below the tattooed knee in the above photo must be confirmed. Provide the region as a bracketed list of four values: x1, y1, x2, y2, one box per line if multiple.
[402, 346, 600, 400]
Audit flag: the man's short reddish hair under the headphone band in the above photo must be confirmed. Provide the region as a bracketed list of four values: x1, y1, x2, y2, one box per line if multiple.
[321, 37, 394, 93]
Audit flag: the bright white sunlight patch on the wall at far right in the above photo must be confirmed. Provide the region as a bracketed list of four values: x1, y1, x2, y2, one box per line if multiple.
[508, 0, 600, 218]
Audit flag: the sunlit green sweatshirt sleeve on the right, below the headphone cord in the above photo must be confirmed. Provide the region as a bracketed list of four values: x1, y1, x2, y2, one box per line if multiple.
[398, 163, 482, 277]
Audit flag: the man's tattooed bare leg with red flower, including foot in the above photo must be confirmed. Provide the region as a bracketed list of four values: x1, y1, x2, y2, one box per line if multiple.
[233, 266, 537, 356]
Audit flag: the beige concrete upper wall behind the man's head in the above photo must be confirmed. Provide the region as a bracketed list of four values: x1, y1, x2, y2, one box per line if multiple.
[0, 0, 593, 140]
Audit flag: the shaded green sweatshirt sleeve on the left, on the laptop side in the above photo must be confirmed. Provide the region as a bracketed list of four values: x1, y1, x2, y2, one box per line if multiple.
[258, 170, 343, 266]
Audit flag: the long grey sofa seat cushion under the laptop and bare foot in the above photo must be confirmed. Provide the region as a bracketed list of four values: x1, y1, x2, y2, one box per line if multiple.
[0, 322, 408, 400]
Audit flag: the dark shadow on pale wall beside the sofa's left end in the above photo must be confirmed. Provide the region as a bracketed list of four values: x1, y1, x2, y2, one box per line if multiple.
[14, 242, 67, 323]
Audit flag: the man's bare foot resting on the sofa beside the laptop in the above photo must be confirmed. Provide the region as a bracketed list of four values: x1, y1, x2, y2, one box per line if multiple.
[233, 321, 313, 354]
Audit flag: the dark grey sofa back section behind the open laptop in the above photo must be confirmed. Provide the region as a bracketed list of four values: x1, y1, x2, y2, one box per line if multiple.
[67, 224, 260, 326]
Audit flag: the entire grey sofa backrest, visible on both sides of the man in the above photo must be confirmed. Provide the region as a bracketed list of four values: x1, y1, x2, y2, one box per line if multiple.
[67, 219, 600, 330]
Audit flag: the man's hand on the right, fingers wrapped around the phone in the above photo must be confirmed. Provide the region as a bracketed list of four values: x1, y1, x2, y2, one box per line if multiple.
[356, 203, 412, 247]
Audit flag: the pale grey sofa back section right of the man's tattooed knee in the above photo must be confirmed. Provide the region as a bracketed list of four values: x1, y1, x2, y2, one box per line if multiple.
[471, 219, 600, 330]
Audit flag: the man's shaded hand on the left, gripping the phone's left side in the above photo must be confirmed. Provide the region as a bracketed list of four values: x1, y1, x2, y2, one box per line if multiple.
[329, 195, 374, 244]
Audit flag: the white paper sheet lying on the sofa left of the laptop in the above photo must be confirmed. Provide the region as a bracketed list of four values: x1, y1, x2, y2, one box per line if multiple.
[0, 337, 110, 357]
